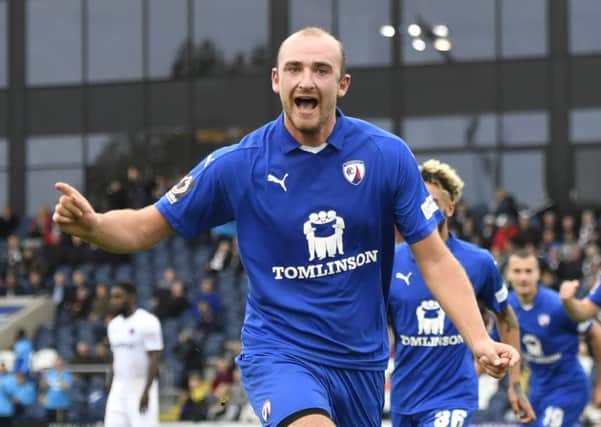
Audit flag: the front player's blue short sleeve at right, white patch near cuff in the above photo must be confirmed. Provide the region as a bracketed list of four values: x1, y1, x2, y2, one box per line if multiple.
[390, 141, 443, 244]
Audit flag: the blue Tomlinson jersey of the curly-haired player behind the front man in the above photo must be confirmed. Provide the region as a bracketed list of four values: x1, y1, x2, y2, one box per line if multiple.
[389, 234, 507, 414]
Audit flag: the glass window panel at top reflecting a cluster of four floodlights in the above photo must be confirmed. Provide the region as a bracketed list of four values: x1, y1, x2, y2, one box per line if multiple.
[400, 0, 495, 63]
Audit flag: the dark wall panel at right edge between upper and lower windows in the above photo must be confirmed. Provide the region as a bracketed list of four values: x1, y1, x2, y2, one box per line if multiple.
[570, 56, 601, 107]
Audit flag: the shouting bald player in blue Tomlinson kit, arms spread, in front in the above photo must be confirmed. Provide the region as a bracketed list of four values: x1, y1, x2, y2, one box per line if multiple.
[53, 28, 519, 427]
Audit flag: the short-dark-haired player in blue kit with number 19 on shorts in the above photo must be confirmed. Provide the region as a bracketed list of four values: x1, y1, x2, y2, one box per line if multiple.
[506, 250, 601, 427]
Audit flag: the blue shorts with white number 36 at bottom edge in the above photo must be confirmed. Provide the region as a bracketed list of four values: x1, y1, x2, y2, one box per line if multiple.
[390, 407, 476, 427]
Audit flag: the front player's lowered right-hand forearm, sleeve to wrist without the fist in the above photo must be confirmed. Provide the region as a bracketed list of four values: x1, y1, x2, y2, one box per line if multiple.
[420, 252, 489, 349]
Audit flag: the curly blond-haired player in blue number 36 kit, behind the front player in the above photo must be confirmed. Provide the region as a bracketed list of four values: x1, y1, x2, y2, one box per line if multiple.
[389, 159, 536, 427]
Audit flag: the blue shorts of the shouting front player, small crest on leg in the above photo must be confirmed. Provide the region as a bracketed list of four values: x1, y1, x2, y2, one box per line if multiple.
[236, 353, 384, 427]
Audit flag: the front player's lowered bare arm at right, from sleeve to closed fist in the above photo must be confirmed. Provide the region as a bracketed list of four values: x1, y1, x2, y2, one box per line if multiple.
[411, 231, 520, 378]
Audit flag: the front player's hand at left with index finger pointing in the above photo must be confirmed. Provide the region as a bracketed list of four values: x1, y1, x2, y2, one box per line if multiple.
[52, 182, 98, 239]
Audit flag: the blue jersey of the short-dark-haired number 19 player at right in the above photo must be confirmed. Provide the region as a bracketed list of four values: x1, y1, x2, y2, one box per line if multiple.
[509, 286, 591, 402]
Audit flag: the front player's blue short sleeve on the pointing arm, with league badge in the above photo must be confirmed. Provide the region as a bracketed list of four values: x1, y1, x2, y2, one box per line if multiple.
[155, 145, 236, 239]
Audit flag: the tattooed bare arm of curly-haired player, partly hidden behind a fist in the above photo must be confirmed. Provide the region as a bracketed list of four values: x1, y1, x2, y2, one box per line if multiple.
[496, 305, 536, 424]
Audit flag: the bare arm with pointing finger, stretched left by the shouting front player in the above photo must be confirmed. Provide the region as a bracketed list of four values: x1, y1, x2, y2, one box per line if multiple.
[52, 182, 173, 253]
